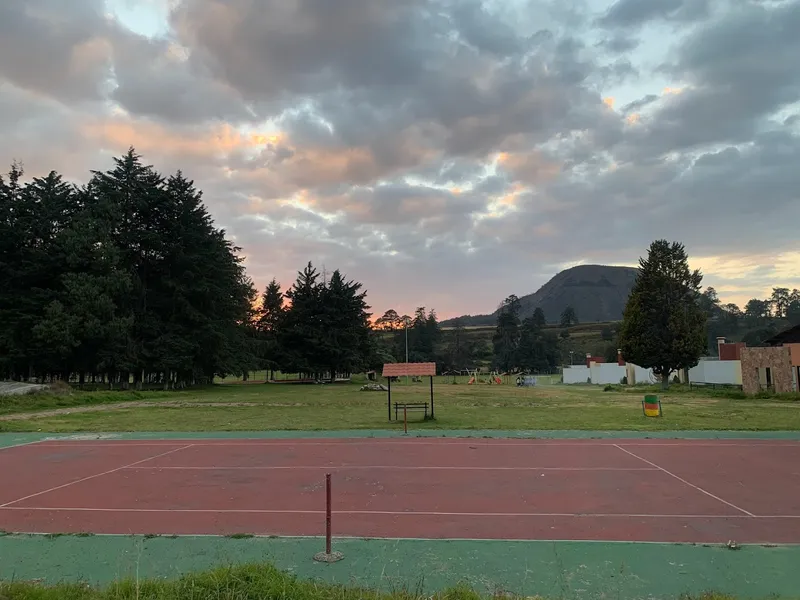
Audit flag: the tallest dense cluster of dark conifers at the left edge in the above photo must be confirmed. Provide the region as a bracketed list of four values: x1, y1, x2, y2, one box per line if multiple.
[0, 149, 257, 387]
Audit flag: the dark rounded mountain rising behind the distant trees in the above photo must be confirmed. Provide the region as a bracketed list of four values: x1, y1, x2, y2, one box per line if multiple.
[442, 265, 637, 327]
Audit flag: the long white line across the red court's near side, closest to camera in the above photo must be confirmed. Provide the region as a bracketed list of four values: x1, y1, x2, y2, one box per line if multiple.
[0, 505, 800, 520]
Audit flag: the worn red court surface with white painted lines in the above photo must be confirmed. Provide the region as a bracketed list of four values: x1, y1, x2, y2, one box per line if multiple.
[0, 438, 800, 544]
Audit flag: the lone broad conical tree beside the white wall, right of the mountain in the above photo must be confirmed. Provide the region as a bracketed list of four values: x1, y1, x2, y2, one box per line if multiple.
[619, 240, 706, 389]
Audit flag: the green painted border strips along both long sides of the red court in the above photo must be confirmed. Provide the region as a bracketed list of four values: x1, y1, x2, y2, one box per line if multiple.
[0, 430, 800, 600]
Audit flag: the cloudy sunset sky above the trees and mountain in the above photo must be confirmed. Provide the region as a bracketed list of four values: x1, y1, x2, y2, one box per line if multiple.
[0, 0, 800, 318]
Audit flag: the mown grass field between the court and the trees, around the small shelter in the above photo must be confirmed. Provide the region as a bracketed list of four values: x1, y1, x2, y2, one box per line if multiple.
[0, 377, 800, 432]
